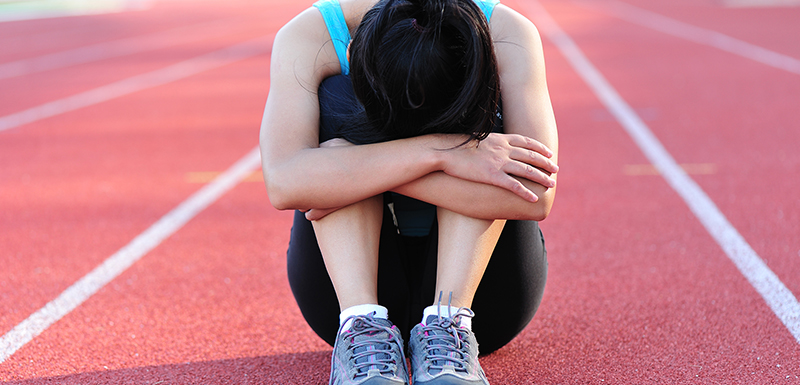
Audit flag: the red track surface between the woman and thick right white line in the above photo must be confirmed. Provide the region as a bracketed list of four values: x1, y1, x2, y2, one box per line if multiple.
[483, 38, 797, 384]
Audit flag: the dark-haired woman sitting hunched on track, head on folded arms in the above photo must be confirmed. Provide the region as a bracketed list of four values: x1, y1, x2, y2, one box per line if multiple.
[260, 0, 558, 385]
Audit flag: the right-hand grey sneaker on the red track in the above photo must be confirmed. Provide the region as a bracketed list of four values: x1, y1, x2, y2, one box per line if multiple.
[409, 308, 489, 385]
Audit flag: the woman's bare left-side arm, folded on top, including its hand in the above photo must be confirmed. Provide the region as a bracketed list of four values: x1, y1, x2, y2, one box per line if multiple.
[260, 9, 546, 214]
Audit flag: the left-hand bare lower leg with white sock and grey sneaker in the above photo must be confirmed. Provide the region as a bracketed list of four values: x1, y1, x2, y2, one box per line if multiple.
[313, 195, 408, 385]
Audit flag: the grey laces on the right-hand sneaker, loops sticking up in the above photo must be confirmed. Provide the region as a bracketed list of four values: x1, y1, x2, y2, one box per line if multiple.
[422, 292, 475, 372]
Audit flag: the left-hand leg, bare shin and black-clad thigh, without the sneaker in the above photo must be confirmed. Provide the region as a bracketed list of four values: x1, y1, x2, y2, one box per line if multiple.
[287, 139, 383, 345]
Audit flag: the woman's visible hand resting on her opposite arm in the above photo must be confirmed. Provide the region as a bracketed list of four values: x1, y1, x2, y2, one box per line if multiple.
[442, 133, 558, 202]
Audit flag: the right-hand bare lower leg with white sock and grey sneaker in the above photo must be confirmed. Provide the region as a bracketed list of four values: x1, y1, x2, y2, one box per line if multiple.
[409, 207, 505, 385]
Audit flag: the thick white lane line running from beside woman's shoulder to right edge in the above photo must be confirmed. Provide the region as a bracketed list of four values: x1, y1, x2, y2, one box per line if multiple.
[518, 0, 800, 342]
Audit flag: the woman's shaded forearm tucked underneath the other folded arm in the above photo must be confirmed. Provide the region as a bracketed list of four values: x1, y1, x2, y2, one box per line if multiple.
[393, 172, 555, 221]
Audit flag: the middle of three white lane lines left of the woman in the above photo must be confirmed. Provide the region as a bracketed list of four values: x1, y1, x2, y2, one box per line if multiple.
[0, 34, 275, 132]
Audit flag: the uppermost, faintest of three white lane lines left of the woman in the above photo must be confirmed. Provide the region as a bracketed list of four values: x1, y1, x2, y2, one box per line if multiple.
[0, 19, 253, 79]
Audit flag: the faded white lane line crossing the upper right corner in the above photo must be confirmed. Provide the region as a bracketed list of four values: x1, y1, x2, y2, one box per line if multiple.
[575, 0, 800, 75]
